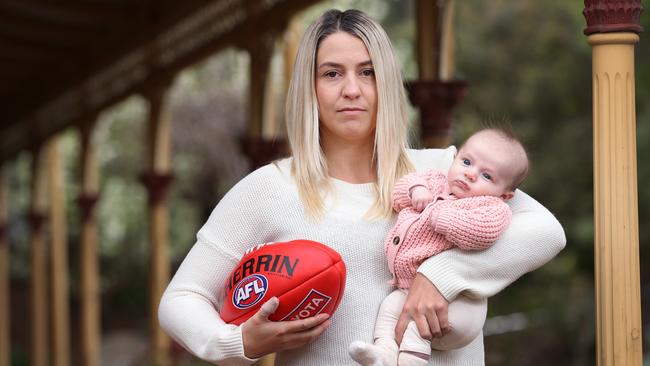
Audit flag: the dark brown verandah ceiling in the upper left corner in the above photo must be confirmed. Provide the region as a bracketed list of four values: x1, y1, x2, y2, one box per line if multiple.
[0, 0, 318, 162]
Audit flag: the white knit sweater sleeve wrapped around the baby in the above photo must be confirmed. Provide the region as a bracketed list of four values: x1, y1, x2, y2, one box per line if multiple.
[418, 191, 566, 301]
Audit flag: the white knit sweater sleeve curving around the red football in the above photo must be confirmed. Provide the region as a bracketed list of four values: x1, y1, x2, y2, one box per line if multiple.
[158, 166, 273, 365]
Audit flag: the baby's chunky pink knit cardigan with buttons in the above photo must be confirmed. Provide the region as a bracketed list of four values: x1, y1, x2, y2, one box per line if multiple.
[384, 171, 512, 288]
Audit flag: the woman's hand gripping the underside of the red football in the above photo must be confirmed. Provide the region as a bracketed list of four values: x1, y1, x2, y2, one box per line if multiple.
[241, 297, 331, 358]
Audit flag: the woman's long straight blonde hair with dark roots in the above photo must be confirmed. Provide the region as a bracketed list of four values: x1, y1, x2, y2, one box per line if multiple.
[286, 10, 413, 218]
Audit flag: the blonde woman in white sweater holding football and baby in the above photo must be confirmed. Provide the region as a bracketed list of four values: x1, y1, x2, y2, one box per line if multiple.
[159, 10, 564, 366]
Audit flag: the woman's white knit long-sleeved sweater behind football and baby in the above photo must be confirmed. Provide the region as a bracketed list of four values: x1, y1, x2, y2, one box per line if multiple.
[159, 147, 565, 366]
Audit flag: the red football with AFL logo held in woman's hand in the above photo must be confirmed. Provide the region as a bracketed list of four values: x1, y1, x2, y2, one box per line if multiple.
[220, 240, 345, 325]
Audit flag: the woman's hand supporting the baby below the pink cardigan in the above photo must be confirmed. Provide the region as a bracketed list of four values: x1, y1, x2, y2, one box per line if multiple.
[395, 273, 451, 344]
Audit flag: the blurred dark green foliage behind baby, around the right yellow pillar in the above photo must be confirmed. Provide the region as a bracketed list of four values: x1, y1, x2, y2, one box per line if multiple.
[455, 0, 650, 365]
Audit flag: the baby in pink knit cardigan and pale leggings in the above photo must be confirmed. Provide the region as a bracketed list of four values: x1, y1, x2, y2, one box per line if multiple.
[350, 128, 528, 366]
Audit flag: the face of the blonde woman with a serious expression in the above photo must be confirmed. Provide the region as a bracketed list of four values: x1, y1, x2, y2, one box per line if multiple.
[315, 32, 377, 145]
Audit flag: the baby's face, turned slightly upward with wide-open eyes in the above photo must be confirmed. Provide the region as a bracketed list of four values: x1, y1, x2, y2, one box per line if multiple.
[447, 131, 516, 200]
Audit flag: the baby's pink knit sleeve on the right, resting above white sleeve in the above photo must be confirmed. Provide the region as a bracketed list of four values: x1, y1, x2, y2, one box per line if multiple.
[434, 196, 512, 250]
